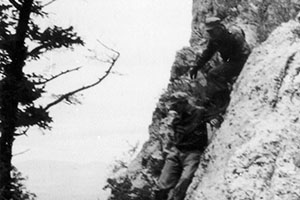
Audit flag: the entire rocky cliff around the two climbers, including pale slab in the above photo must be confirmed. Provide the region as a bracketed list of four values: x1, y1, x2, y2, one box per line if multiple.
[108, 0, 300, 200]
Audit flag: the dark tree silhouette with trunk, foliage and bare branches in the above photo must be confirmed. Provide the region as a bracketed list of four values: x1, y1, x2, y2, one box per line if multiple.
[0, 0, 119, 200]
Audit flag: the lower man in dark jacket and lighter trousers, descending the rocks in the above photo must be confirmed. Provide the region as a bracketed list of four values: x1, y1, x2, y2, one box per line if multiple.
[155, 92, 223, 200]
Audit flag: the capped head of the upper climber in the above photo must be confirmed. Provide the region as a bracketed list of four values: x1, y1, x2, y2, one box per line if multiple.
[205, 17, 226, 39]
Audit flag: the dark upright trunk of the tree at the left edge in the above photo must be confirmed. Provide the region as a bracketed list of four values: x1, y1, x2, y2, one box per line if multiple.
[0, 0, 33, 199]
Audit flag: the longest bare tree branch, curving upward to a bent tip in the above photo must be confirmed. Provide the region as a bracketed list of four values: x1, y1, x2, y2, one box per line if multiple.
[44, 46, 120, 110]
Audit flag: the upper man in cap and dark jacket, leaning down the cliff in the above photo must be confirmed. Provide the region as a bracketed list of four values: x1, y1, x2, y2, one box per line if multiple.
[190, 17, 251, 96]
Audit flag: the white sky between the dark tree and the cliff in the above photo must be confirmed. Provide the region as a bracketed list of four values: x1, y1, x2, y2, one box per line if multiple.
[14, 0, 192, 163]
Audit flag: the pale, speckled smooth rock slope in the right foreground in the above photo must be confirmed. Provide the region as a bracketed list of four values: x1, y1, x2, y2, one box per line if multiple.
[187, 18, 300, 200]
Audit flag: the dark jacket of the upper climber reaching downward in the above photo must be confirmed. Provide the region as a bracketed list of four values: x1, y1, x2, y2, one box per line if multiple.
[197, 27, 251, 69]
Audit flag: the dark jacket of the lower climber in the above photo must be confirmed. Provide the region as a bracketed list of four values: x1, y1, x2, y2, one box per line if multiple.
[172, 105, 219, 151]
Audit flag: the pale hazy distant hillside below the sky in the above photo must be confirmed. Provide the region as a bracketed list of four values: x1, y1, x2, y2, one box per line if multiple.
[16, 160, 108, 200]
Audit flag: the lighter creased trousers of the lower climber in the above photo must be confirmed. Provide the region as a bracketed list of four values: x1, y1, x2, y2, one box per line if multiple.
[158, 149, 201, 200]
